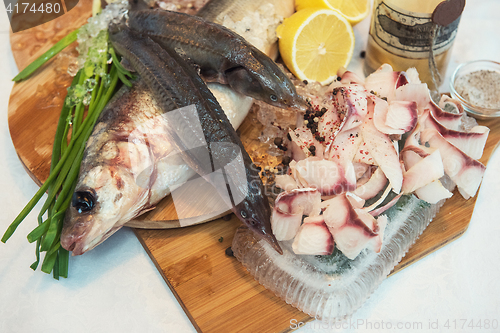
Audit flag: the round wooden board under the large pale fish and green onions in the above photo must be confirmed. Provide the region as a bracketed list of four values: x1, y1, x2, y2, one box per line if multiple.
[8, 1, 246, 229]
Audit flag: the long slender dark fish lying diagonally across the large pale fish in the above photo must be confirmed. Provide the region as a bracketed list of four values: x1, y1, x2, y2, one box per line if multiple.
[110, 29, 282, 253]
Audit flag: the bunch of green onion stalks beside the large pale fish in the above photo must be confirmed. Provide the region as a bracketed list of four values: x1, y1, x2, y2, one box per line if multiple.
[2, 19, 133, 279]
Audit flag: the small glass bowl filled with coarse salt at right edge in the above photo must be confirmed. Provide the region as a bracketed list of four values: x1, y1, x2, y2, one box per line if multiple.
[450, 60, 500, 119]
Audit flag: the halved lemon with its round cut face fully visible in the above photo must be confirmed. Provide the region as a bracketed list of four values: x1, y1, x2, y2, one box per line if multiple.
[276, 8, 354, 85]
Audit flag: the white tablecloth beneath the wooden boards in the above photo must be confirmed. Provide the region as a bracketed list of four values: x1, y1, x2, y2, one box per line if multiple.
[0, 0, 500, 333]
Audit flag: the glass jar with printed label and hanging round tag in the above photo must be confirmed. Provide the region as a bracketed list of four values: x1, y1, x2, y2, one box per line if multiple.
[364, 0, 465, 91]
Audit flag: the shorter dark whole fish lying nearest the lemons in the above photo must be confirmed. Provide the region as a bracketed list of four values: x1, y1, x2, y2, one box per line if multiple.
[128, 10, 305, 110]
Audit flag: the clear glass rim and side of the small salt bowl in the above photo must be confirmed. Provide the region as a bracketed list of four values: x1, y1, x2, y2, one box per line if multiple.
[450, 60, 500, 119]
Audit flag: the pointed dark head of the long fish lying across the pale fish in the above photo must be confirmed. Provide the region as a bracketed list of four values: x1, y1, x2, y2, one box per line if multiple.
[233, 186, 283, 254]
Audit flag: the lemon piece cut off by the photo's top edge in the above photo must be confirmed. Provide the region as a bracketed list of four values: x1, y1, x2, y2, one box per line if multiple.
[295, 0, 370, 25]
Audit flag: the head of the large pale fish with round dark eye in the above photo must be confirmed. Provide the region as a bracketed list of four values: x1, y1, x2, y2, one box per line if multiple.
[61, 165, 148, 255]
